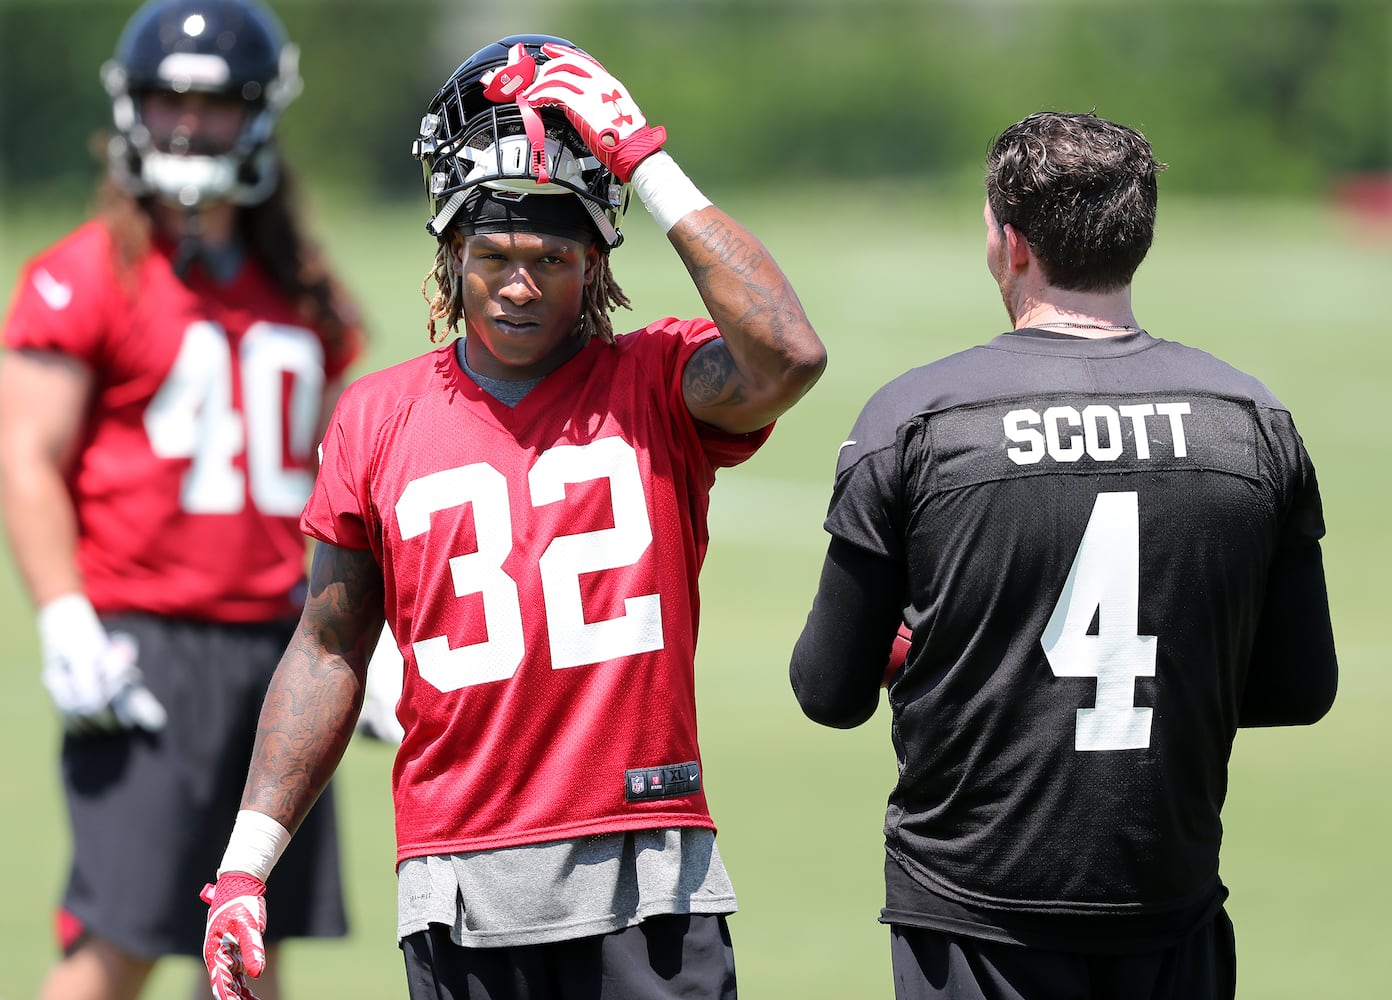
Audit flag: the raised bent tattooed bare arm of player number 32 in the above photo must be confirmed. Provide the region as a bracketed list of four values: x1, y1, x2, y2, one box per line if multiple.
[667, 205, 827, 433]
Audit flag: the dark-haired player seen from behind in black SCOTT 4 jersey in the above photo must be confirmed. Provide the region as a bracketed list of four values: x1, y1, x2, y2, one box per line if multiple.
[791, 113, 1336, 1000]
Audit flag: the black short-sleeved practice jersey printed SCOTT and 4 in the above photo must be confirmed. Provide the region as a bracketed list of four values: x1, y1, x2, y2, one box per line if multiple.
[825, 330, 1332, 950]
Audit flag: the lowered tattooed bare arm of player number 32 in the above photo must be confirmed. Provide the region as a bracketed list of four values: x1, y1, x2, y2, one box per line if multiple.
[242, 542, 383, 833]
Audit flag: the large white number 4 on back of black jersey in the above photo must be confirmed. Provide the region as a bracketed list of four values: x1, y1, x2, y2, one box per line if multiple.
[1040, 493, 1155, 751]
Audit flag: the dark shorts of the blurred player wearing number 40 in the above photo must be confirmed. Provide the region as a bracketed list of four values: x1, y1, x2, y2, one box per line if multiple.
[58, 616, 347, 958]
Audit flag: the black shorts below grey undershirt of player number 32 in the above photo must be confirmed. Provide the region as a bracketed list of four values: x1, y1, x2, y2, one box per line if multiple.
[401, 914, 738, 1000]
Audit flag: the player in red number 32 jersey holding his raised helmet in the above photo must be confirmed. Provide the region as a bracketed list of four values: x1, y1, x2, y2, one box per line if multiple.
[206, 35, 825, 1000]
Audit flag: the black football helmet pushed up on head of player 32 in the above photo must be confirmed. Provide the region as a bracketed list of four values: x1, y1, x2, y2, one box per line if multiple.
[411, 35, 629, 249]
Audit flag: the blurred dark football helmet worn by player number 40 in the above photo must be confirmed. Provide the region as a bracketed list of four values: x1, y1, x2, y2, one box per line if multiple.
[102, 0, 301, 208]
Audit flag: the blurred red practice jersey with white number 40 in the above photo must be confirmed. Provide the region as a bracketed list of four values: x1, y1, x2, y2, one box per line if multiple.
[4, 221, 355, 623]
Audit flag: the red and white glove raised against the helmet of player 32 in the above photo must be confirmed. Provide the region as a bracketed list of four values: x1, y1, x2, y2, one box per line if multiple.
[520, 42, 667, 184]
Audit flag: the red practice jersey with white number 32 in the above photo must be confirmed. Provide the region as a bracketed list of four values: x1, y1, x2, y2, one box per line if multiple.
[303, 319, 771, 859]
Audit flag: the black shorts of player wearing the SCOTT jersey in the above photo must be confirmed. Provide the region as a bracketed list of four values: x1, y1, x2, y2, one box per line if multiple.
[889, 909, 1237, 1000]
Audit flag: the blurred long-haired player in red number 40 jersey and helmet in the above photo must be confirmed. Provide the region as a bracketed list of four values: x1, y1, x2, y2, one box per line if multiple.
[0, 0, 361, 1000]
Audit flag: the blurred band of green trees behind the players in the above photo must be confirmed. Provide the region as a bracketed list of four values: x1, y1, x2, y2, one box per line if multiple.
[0, 0, 1392, 199]
